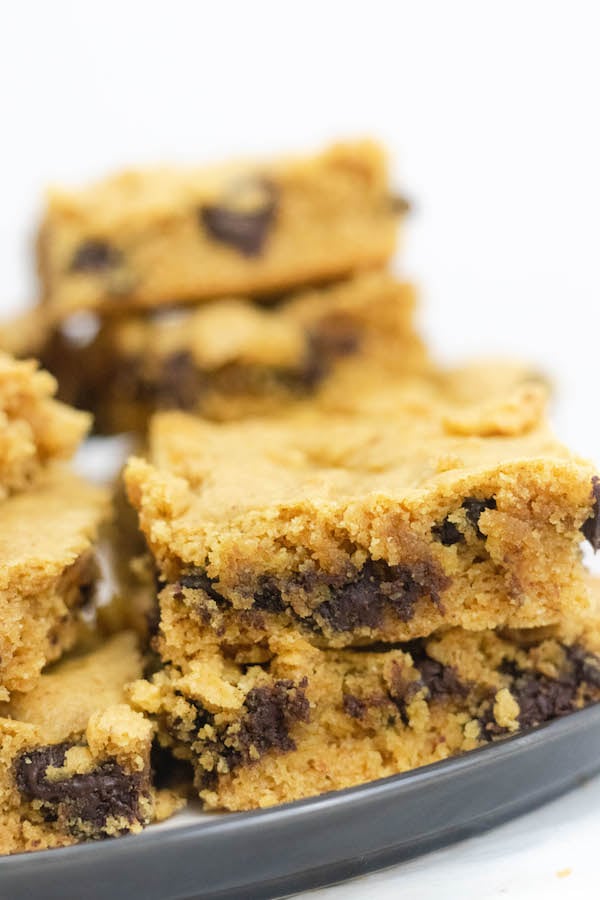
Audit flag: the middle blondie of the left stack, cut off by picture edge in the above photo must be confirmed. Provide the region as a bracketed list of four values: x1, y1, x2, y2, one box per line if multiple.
[0, 465, 108, 699]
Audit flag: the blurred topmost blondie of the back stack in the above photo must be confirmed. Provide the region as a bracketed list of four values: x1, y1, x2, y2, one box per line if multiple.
[39, 141, 402, 317]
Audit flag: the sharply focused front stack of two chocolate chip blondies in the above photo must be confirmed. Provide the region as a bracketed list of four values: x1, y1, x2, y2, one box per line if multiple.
[125, 369, 600, 810]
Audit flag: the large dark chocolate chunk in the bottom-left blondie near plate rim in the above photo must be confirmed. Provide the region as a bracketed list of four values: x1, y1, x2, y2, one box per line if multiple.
[15, 744, 142, 828]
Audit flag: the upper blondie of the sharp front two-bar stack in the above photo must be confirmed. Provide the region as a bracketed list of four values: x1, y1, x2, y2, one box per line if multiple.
[126, 385, 600, 646]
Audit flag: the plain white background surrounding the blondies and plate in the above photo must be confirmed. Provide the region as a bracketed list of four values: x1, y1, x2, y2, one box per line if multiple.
[0, 0, 600, 900]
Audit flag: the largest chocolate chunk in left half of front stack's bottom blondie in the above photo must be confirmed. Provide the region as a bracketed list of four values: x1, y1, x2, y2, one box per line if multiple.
[237, 677, 310, 757]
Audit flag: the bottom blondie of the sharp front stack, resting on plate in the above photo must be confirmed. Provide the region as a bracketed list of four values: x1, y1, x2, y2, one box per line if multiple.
[130, 596, 600, 810]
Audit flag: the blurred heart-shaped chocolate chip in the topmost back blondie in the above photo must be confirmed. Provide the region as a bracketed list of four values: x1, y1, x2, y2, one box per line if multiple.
[199, 179, 278, 256]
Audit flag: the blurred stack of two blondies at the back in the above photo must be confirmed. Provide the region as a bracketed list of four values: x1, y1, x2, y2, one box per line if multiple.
[25, 141, 420, 433]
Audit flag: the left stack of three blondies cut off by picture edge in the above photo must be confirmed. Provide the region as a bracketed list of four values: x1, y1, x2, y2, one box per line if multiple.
[0, 353, 180, 853]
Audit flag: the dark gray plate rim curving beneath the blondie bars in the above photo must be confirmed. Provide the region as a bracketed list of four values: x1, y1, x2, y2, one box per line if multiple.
[0, 704, 600, 900]
